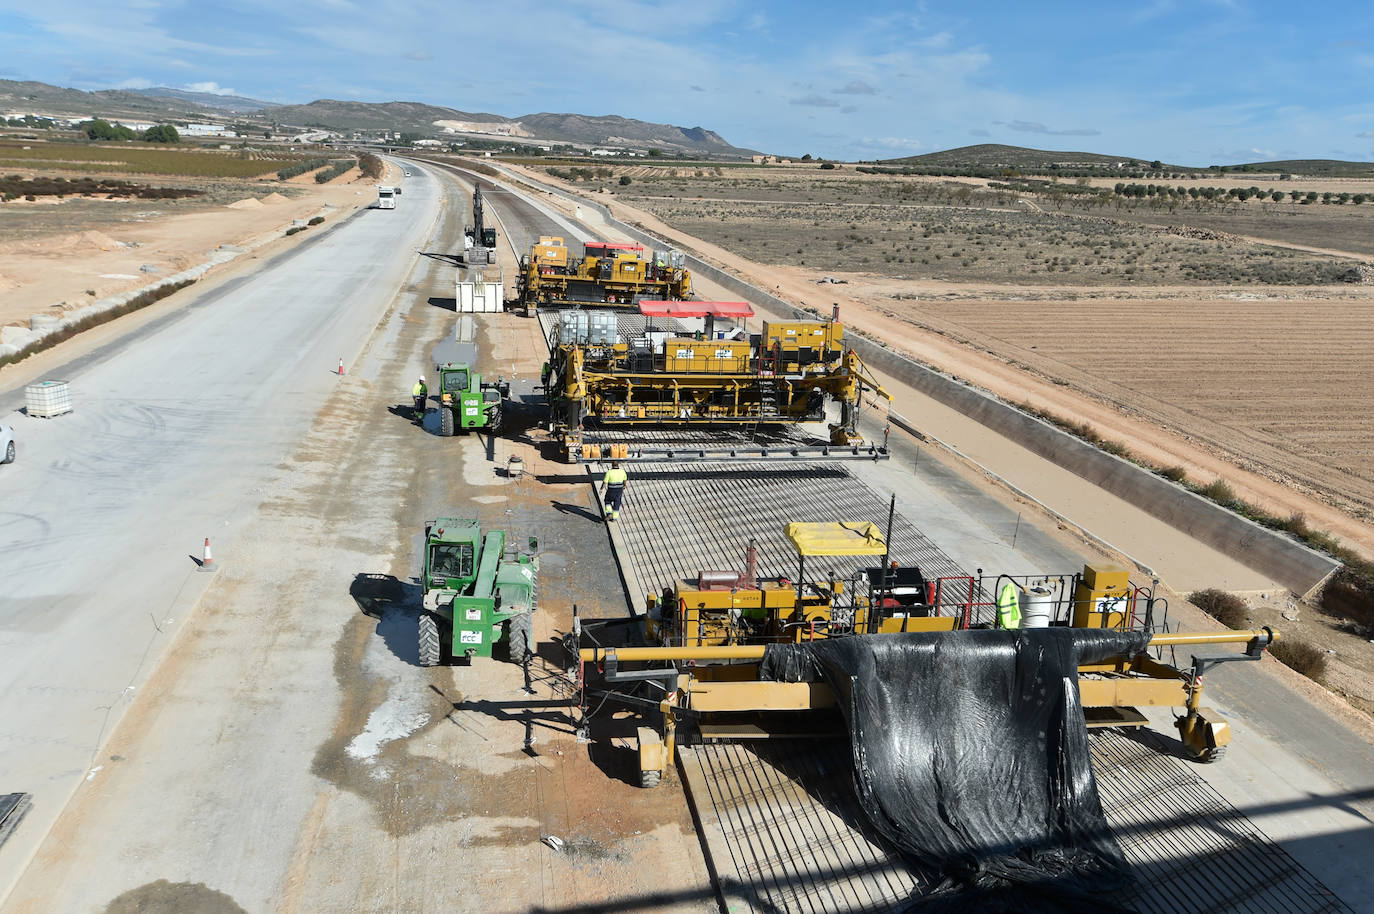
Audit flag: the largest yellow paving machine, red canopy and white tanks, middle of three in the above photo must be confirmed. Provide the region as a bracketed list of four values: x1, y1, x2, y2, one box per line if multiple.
[545, 301, 892, 462]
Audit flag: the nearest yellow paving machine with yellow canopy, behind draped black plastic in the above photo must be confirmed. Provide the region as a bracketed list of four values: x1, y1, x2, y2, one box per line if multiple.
[573, 522, 1278, 786]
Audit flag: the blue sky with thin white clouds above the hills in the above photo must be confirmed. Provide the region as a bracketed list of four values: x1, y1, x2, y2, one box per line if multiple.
[0, 0, 1374, 165]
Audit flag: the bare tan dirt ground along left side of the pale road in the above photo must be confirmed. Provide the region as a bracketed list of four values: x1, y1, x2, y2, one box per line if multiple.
[0, 162, 400, 327]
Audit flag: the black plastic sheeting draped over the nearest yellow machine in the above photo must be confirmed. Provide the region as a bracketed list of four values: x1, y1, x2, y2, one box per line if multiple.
[760, 628, 1149, 911]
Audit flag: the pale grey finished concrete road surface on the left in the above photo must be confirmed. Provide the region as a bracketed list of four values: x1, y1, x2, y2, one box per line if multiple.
[0, 156, 441, 895]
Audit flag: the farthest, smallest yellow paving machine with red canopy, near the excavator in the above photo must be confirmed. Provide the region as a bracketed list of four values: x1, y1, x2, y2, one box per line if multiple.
[518, 235, 691, 313]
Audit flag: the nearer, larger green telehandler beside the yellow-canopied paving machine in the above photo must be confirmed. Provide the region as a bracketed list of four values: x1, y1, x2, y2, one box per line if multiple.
[419, 517, 539, 667]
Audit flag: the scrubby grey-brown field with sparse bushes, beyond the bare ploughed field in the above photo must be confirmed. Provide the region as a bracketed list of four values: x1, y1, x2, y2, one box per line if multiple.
[607, 169, 1374, 286]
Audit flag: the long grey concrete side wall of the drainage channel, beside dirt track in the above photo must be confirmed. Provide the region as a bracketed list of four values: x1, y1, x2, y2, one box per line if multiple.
[494, 160, 1341, 598]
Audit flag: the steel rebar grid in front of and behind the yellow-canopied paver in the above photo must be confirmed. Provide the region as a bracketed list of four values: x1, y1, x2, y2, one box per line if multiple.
[611, 463, 1351, 914]
